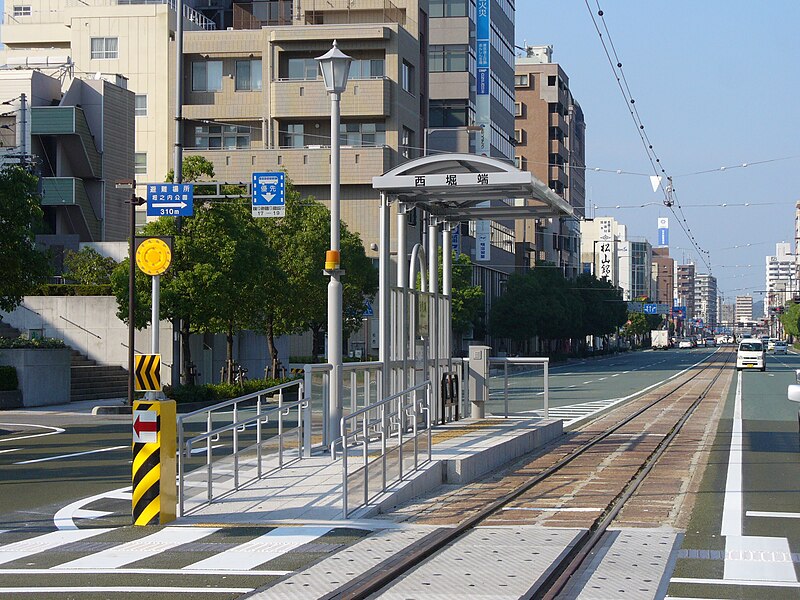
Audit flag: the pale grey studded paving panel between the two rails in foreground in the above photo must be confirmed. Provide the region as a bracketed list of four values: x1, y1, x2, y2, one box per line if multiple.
[377, 527, 580, 600]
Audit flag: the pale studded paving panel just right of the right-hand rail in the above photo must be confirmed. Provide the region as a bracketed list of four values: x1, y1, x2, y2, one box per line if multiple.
[559, 529, 679, 600]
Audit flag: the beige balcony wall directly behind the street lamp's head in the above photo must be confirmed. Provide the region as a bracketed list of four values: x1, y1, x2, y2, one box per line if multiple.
[271, 78, 392, 119]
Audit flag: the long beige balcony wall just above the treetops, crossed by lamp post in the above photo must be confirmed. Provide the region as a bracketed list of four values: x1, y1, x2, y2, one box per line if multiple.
[186, 146, 394, 186]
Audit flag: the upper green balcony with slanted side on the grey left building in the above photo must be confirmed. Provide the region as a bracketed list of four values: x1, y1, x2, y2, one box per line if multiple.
[31, 106, 103, 179]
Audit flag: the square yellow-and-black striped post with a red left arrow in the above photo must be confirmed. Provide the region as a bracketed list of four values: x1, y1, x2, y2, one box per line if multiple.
[132, 400, 178, 525]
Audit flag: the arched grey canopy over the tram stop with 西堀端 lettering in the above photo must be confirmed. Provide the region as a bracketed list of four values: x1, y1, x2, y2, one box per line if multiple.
[372, 154, 573, 221]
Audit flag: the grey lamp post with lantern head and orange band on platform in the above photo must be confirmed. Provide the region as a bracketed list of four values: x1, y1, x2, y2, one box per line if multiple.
[316, 40, 353, 444]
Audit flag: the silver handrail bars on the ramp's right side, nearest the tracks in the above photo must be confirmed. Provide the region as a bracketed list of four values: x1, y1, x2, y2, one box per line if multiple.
[340, 380, 432, 518]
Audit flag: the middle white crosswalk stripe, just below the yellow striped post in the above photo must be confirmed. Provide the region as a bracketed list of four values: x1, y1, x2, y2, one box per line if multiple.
[58, 527, 219, 569]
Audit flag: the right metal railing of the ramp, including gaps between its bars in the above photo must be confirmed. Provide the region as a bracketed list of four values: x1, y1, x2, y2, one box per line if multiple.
[338, 381, 431, 518]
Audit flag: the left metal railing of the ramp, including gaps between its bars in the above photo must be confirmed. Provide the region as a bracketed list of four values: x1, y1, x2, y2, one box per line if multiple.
[177, 380, 311, 515]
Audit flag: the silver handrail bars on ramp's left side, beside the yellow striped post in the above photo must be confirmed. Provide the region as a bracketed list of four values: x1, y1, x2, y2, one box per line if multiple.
[177, 380, 311, 515]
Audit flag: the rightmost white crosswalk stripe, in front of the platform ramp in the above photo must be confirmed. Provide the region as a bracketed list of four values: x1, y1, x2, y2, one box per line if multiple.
[183, 527, 332, 571]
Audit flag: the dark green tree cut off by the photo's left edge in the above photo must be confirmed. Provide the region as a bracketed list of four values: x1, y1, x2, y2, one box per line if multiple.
[0, 165, 51, 311]
